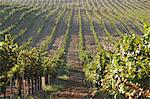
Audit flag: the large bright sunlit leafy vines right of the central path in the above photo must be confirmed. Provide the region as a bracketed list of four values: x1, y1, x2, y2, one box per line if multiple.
[84, 24, 150, 96]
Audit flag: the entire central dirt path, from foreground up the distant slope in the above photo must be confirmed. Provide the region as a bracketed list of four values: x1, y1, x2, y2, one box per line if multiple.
[47, 11, 94, 99]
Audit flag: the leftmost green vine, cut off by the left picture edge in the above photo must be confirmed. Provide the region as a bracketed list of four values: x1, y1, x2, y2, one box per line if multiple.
[0, 35, 18, 91]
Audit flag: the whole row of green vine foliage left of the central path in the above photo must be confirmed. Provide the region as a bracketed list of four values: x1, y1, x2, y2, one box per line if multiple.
[0, 35, 65, 92]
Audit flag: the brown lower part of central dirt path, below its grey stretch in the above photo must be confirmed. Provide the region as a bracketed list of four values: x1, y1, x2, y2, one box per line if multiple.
[57, 35, 90, 99]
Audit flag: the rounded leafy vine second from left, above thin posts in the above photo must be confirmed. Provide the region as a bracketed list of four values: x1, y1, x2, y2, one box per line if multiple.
[16, 48, 46, 79]
